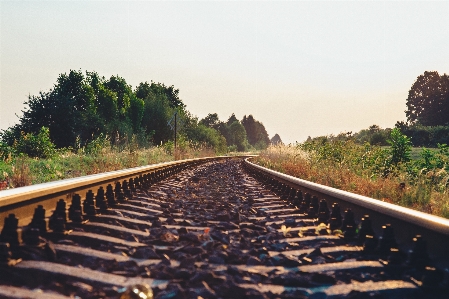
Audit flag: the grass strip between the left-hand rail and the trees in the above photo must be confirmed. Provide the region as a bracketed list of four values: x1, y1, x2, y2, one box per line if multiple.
[0, 147, 215, 190]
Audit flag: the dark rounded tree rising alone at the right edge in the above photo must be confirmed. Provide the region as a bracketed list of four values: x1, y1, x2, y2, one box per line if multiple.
[405, 71, 449, 126]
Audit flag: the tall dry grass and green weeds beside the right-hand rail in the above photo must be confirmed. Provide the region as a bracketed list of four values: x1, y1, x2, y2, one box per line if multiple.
[255, 141, 449, 218]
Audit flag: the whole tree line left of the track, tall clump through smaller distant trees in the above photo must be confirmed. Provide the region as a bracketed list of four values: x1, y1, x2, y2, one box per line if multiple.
[0, 70, 270, 157]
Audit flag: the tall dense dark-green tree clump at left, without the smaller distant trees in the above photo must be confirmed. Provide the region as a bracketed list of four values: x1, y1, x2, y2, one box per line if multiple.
[1, 70, 184, 153]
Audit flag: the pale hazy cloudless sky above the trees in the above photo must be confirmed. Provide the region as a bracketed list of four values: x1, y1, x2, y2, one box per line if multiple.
[0, 0, 449, 143]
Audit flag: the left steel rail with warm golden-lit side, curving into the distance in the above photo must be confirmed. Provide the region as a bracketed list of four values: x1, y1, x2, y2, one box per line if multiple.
[0, 155, 250, 229]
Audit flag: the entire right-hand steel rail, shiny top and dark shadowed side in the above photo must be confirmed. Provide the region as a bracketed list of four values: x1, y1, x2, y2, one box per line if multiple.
[244, 158, 449, 267]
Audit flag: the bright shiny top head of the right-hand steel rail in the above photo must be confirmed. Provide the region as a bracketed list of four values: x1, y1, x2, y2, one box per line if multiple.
[245, 158, 449, 236]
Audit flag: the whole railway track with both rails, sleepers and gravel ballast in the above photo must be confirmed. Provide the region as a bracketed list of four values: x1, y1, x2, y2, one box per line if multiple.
[0, 158, 449, 299]
